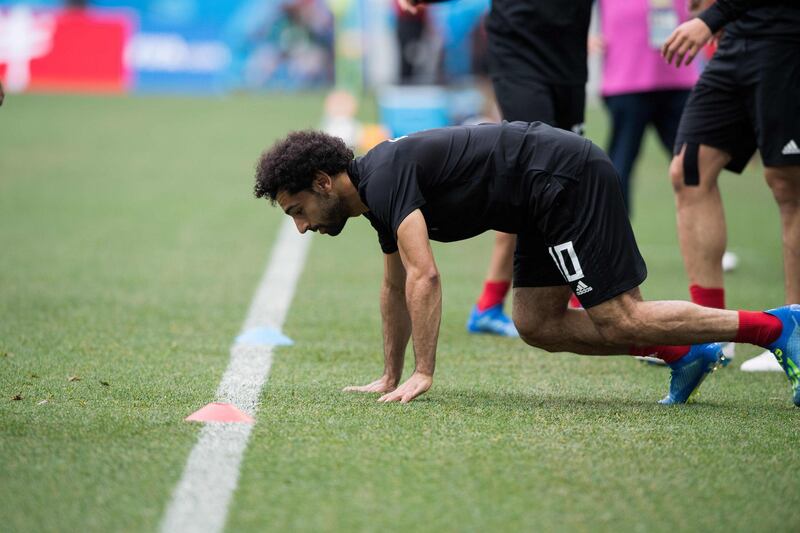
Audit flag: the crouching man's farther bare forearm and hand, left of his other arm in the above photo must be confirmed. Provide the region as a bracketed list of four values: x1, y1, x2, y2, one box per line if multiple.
[344, 252, 411, 393]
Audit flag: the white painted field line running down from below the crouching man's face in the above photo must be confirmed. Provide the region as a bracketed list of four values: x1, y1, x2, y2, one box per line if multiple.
[161, 219, 311, 533]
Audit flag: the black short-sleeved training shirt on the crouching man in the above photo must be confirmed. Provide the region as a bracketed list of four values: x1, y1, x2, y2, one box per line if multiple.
[348, 122, 591, 254]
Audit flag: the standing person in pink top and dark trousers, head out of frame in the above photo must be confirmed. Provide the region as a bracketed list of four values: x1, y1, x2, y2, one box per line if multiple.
[592, 0, 698, 214]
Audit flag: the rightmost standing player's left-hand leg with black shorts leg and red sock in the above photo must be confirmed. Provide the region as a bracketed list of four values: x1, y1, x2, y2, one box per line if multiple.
[670, 62, 756, 364]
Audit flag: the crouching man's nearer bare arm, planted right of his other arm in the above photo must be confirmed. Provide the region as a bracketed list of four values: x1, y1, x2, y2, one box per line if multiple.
[379, 209, 442, 403]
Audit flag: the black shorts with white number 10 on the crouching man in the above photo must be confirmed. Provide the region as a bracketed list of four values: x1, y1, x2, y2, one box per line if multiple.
[514, 145, 647, 308]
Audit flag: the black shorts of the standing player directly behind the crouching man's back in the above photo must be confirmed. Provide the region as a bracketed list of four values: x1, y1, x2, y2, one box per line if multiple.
[492, 76, 586, 135]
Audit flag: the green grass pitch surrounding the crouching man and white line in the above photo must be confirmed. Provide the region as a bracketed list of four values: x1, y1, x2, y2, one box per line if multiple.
[0, 94, 800, 532]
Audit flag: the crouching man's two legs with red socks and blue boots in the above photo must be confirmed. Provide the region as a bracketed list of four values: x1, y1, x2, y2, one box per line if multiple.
[514, 287, 800, 406]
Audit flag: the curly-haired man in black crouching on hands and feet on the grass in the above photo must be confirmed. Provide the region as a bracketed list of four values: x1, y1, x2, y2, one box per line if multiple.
[255, 122, 800, 405]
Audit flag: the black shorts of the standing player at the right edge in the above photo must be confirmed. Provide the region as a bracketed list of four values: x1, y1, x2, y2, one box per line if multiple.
[675, 35, 800, 172]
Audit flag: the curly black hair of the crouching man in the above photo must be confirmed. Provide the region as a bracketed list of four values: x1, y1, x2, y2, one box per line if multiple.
[253, 130, 353, 204]
